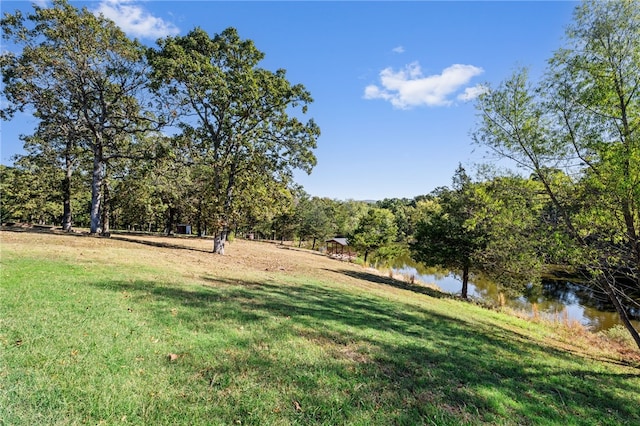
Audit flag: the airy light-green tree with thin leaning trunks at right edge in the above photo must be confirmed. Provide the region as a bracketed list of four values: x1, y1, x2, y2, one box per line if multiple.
[474, 0, 640, 347]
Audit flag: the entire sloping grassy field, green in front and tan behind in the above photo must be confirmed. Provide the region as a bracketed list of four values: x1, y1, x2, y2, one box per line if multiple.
[0, 231, 640, 426]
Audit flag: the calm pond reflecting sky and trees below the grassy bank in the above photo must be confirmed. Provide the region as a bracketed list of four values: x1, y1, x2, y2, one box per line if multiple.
[391, 261, 640, 331]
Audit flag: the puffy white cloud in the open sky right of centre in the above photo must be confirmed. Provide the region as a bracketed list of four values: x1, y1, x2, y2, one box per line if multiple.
[364, 62, 484, 109]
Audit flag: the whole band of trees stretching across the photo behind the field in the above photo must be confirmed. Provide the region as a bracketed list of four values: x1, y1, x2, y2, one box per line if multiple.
[0, 0, 640, 347]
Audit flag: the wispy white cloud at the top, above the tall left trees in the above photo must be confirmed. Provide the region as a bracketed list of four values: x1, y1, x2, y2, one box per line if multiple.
[94, 0, 180, 39]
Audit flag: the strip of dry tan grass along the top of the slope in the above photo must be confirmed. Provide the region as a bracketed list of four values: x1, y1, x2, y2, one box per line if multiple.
[0, 227, 399, 294]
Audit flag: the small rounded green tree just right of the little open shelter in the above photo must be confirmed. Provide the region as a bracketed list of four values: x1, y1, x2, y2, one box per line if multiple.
[347, 208, 398, 264]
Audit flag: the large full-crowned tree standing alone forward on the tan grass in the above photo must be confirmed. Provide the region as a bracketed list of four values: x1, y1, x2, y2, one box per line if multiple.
[148, 28, 320, 254]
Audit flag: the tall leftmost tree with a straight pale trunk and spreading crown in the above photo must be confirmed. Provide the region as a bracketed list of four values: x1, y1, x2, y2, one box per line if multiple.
[1, 0, 154, 233]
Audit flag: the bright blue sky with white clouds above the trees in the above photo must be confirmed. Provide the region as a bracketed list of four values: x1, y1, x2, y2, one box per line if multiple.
[0, 0, 578, 200]
